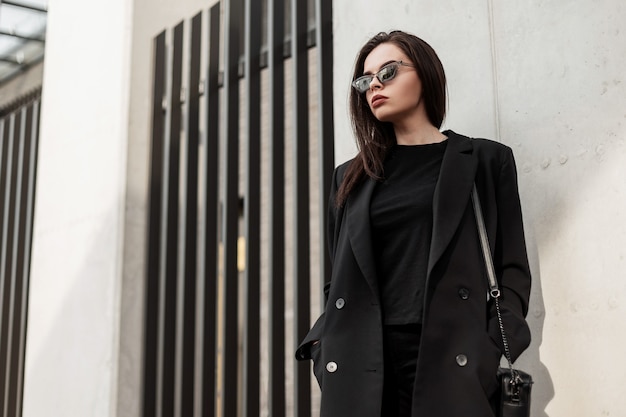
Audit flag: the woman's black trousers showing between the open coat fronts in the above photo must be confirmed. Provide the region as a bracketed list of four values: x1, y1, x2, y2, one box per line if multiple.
[381, 324, 422, 417]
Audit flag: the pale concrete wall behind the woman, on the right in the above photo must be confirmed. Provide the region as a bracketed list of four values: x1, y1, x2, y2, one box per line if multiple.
[334, 0, 626, 417]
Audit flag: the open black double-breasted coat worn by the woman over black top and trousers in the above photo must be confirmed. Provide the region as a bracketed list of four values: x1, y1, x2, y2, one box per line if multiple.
[296, 131, 531, 417]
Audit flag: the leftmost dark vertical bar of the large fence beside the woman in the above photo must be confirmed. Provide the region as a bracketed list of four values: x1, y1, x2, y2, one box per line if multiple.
[142, 31, 165, 417]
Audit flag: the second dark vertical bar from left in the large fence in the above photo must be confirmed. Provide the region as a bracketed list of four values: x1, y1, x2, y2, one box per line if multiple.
[161, 21, 185, 417]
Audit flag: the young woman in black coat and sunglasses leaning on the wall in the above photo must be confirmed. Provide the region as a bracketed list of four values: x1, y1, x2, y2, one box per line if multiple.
[296, 31, 531, 417]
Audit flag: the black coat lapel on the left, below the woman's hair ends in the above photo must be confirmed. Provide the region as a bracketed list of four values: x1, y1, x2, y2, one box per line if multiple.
[346, 178, 378, 295]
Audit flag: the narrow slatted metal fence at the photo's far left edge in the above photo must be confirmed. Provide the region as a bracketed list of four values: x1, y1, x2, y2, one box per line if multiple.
[0, 90, 41, 417]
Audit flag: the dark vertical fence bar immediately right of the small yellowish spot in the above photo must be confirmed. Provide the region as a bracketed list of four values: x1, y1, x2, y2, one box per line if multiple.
[242, 0, 262, 417]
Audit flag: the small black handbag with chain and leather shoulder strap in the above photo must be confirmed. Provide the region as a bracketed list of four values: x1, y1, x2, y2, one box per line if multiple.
[472, 184, 533, 417]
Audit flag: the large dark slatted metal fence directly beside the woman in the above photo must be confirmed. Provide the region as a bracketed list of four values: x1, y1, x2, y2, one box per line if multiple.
[143, 0, 334, 417]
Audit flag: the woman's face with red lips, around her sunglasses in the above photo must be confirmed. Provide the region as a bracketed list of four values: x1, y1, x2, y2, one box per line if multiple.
[363, 43, 425, 124]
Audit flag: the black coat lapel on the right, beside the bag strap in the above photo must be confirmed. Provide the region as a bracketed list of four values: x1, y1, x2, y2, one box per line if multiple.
[427, 131, 477, 277]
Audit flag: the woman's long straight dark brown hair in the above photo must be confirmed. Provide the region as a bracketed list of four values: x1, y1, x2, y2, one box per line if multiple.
[335, 31, 446, 207]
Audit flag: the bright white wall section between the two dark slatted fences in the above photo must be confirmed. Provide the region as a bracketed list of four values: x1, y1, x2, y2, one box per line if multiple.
[23, 0, 131, 417]
